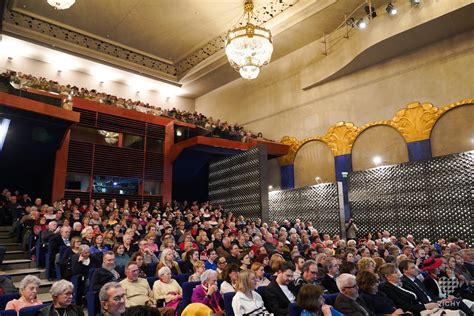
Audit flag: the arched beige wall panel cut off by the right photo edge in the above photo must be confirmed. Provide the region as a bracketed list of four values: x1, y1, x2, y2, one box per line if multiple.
[430, 104, 474, 157]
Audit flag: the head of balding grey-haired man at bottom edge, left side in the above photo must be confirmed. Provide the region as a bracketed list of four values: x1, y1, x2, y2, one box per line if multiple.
[99, 282, 125, 316]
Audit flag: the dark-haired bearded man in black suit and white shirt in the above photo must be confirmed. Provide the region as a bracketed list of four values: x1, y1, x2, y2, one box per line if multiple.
[264, 261, 296, 316]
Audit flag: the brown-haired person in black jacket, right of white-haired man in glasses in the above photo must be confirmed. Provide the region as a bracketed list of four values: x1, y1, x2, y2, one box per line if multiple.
[379, 263, 439, 315]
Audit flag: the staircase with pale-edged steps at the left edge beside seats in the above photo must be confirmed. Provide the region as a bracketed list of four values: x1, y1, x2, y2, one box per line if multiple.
[0, 226, 53, 303]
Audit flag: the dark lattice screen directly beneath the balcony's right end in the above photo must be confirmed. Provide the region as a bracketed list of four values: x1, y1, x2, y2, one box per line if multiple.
[209, 146, 268, 220]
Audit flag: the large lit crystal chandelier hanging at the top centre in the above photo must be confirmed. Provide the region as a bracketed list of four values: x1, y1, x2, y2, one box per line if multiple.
[225, 0, 273, 80]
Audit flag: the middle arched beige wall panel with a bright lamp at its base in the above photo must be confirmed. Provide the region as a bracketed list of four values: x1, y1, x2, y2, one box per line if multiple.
[352, 125, 408, 171]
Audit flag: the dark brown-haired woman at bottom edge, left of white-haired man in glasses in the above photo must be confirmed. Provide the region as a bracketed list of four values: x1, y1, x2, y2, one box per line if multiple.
[296, 284, 331, 316]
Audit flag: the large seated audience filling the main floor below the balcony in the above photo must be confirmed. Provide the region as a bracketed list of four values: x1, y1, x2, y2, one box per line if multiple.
[0, 189, 474, 316]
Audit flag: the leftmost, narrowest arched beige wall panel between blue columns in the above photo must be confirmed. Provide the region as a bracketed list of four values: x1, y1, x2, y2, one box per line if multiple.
[294, 141, 336, 188]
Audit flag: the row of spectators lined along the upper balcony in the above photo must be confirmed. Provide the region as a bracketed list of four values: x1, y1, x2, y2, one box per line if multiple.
[1, 70, 270, 142]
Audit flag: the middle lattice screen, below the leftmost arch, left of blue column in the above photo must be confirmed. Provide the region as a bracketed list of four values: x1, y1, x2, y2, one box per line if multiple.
[268, 183, 340, 235]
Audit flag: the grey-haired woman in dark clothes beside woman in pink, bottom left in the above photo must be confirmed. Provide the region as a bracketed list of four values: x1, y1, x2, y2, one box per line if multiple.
[39, 280, 84, 316]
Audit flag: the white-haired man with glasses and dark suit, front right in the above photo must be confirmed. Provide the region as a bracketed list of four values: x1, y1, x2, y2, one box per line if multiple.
[334, 273, 375, 316]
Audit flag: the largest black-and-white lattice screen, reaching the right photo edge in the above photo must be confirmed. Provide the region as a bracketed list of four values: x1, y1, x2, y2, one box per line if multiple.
[348, 151, 474, 245]
